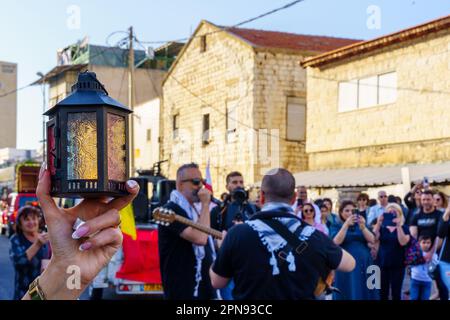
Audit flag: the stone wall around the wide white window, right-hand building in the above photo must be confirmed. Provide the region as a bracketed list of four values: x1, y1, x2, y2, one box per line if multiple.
[306, 30, 450, 170]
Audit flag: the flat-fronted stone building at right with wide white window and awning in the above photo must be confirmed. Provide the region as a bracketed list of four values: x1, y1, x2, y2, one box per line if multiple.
[297, 16, 450, 200]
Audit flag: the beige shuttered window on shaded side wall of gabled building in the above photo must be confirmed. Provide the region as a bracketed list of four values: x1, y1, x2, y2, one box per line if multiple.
[286, 97, 306, 141]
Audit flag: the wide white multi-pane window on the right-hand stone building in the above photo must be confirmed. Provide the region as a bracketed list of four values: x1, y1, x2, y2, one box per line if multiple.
[338, 72, 397, 112]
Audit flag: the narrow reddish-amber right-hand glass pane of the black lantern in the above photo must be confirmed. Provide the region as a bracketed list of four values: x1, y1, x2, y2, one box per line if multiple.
[107, 113, 126, 181]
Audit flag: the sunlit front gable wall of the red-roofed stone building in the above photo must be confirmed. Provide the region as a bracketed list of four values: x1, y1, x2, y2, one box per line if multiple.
[160, 24, 255, 192]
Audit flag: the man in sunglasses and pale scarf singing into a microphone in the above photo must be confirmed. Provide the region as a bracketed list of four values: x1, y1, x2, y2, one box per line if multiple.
[158, 163, 216, 300]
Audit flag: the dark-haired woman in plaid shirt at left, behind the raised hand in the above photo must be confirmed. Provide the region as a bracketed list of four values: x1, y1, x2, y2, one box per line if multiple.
[10, 206, 49, 300]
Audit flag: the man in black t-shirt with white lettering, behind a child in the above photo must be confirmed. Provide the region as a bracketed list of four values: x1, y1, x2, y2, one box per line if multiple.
[409, 190, 442, 242]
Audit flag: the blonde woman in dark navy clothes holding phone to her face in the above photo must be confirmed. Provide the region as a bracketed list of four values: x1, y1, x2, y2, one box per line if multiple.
[374, 203, 410, 300]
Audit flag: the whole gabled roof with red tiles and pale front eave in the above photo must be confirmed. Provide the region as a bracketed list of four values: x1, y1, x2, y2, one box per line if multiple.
[162, 20, 362, 85]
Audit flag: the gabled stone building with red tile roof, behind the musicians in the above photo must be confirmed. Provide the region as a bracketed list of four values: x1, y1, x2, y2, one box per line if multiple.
[160, 21, 356, 192]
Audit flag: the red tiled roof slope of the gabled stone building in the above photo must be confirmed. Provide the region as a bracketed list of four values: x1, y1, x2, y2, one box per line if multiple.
[227, 28, 362, 52]
